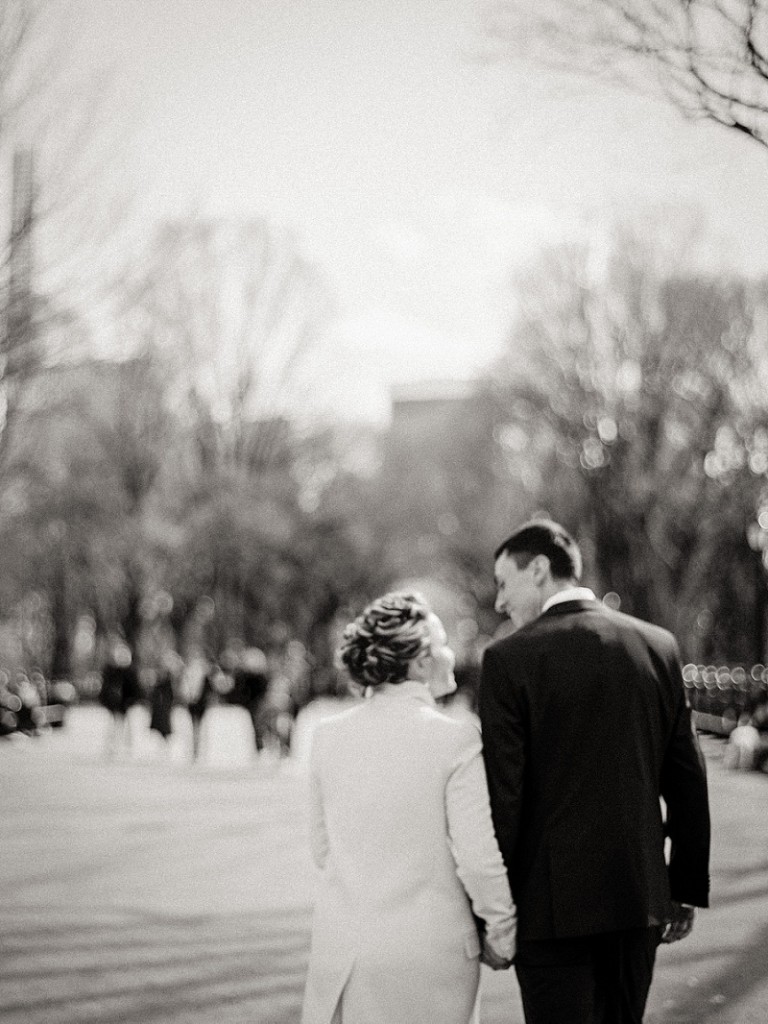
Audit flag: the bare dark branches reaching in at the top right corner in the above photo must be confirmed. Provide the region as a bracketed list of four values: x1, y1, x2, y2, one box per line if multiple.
[484, 0, 768, 145]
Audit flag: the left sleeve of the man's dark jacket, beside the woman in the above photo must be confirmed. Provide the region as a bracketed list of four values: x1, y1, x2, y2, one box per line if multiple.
[479, 647, 525, 871]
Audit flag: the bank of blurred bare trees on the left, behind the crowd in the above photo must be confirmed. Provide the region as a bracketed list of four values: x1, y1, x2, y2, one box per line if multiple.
[0, 215, 387, 685]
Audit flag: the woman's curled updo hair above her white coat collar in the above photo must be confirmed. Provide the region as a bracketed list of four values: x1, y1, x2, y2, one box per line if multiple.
[338, 591, 431, 687]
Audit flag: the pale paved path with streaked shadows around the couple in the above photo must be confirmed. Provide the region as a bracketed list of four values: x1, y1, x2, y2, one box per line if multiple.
[0, 709, 768, 1024]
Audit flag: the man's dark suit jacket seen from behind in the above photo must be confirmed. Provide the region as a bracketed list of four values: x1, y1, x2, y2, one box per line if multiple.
[480, 601, 710, 939]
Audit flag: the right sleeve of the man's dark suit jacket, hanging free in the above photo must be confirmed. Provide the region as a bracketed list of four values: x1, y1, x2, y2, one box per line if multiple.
[660, 647, 711, 906]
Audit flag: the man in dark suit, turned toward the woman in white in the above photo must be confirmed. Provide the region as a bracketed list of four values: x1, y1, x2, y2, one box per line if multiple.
[480, 520, 710, 1024]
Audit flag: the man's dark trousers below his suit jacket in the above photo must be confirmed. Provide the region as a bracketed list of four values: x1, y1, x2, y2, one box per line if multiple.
[515, 928, 662, 1024]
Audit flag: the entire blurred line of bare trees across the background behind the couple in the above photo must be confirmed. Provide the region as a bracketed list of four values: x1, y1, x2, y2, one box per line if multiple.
[0, 208, 768, 692]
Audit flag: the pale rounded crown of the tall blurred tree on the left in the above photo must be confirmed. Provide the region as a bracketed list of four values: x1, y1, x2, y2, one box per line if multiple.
[126, 219, 330, 467]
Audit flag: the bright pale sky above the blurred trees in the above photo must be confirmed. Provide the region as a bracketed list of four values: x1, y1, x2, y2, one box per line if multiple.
[41, 0, 768, 419]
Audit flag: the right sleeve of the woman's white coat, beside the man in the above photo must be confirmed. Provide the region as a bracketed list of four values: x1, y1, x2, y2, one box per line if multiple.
[445, 725, 516, 959]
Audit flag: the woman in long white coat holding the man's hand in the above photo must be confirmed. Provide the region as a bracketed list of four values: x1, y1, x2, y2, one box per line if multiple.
[301, 593, 515, 1024]
